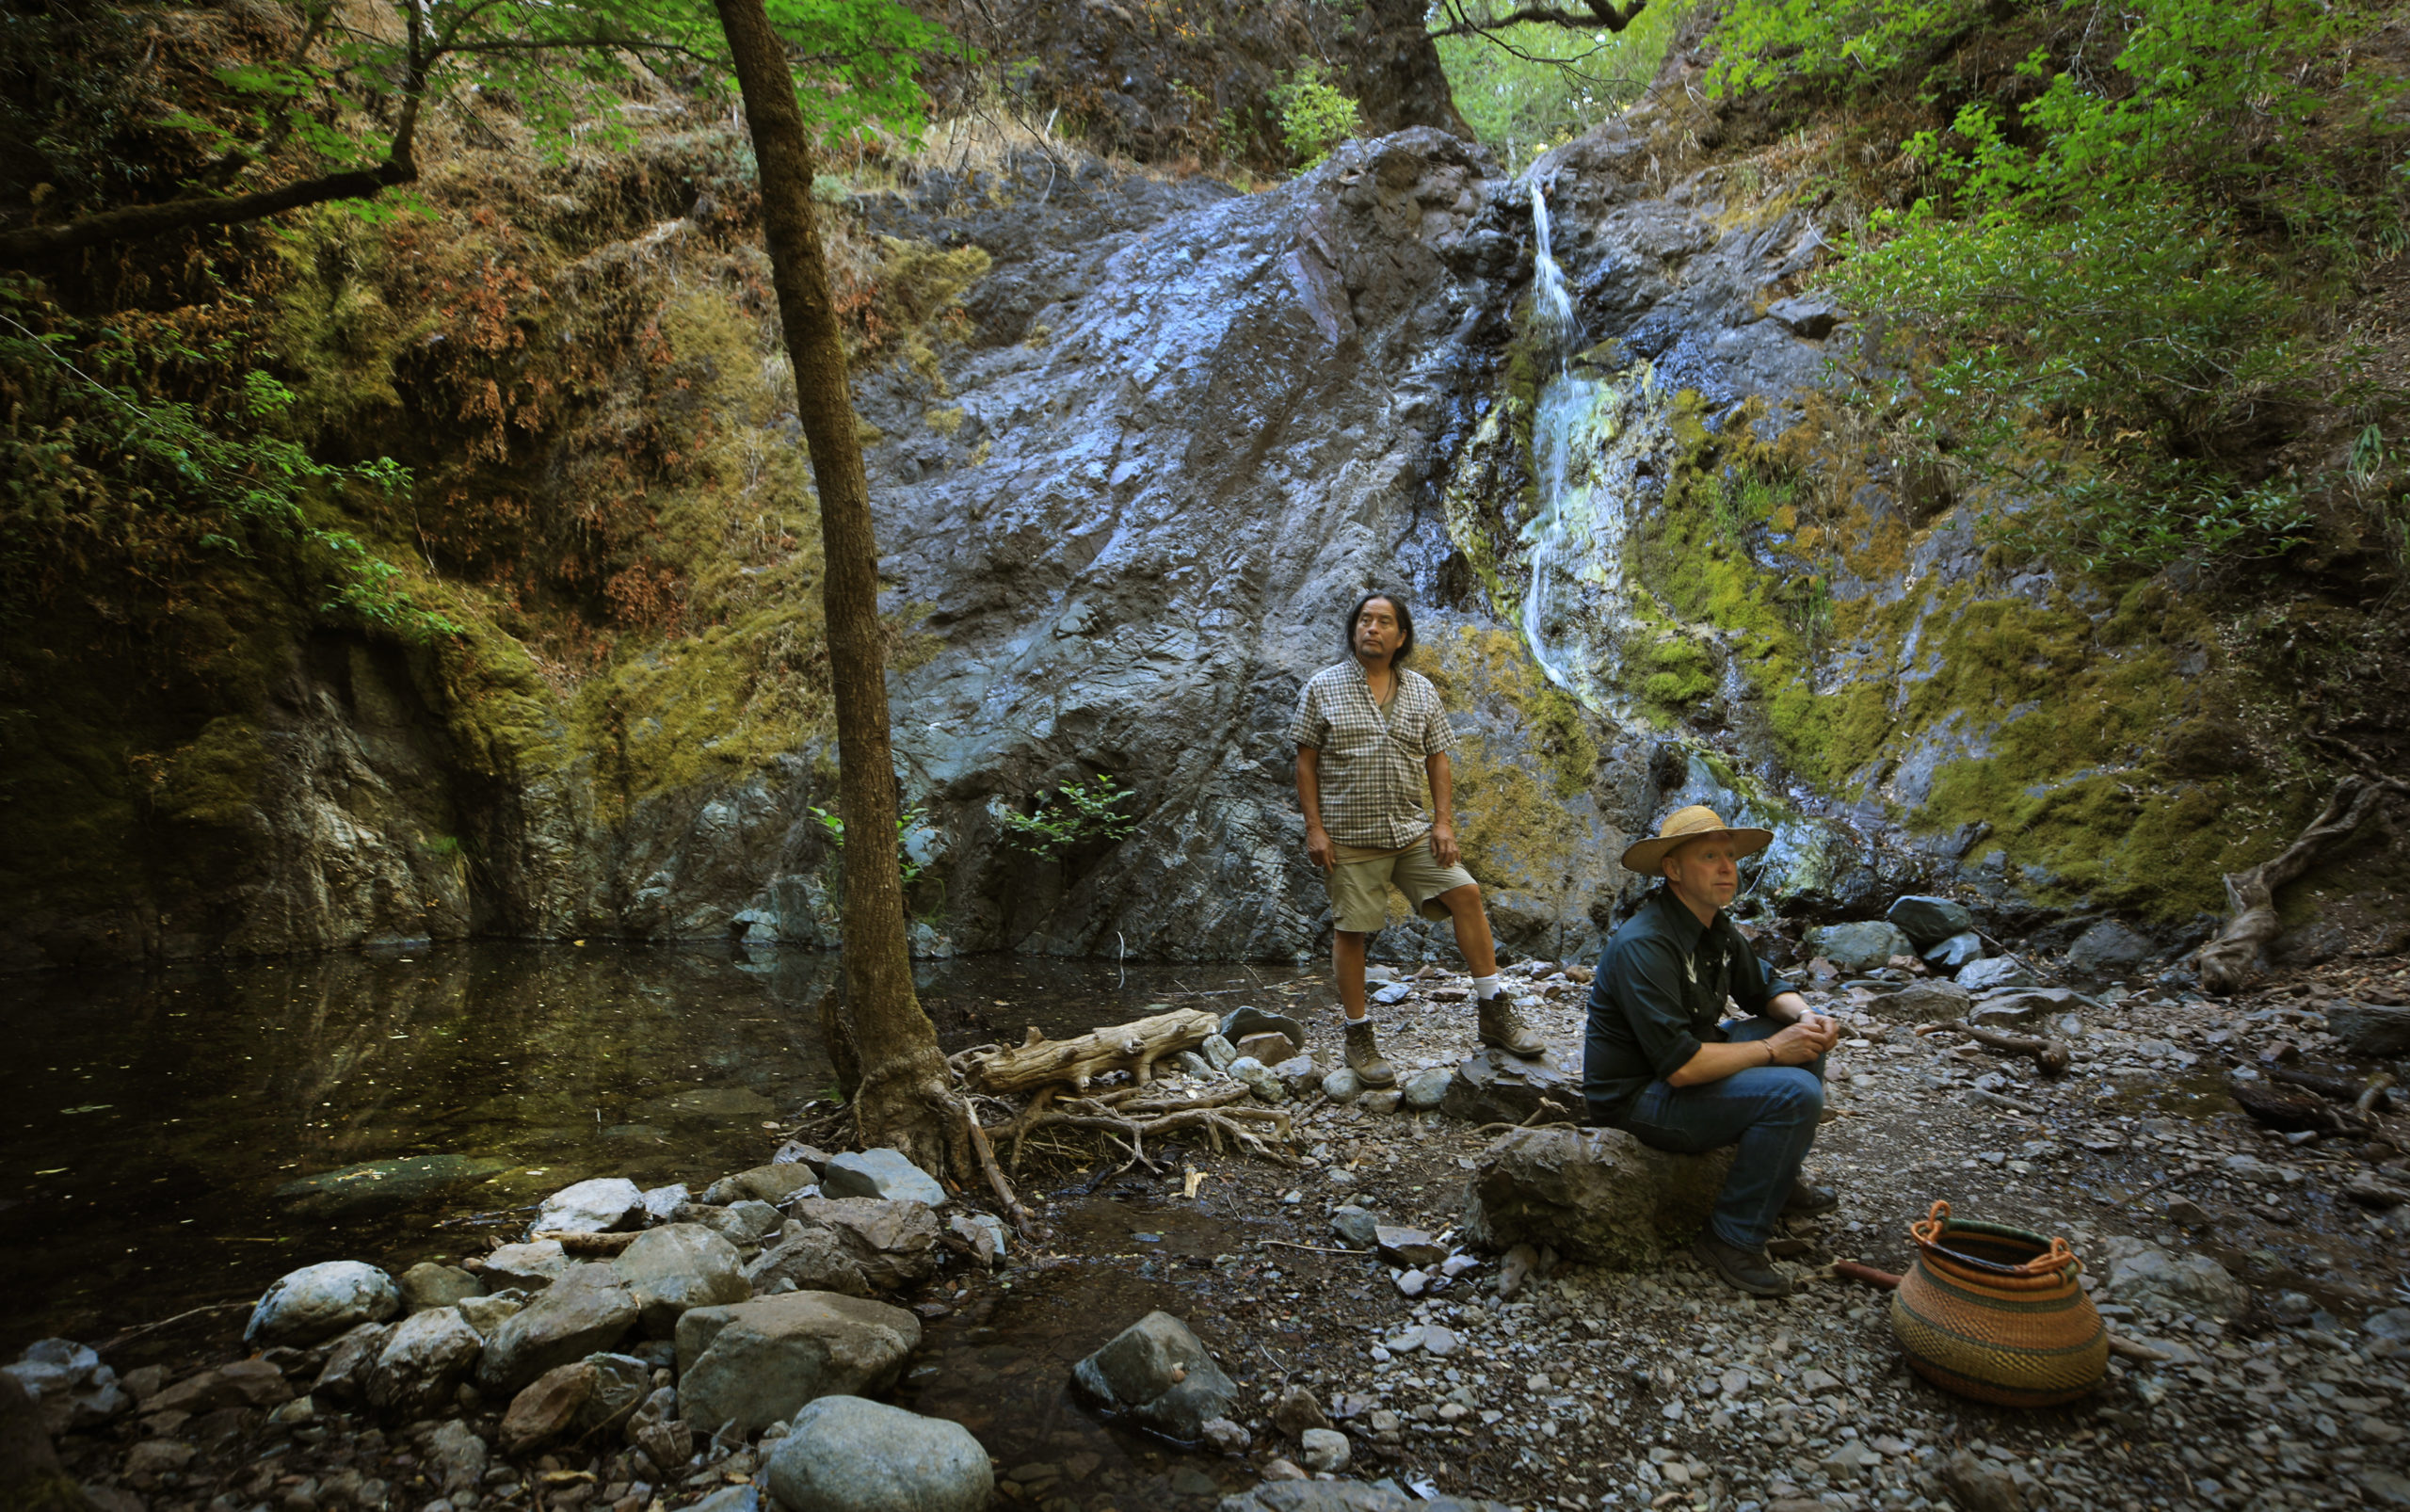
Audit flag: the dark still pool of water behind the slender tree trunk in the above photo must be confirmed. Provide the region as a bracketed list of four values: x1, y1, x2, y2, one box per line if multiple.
[0, 943, 1296, 1367]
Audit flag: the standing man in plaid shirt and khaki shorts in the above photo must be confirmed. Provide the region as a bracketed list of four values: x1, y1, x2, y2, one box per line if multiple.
[1290, 593, 1545, 1087]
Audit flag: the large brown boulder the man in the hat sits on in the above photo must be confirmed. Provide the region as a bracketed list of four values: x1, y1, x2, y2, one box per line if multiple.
[1465, 1129, 1733, 1271]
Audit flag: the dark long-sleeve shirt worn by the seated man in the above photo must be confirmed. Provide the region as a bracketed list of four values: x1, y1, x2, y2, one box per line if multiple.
[1581, 885, 1795, 1124]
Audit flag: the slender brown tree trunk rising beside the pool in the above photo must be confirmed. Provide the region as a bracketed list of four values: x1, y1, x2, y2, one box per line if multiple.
[715, 0, 972, 1180]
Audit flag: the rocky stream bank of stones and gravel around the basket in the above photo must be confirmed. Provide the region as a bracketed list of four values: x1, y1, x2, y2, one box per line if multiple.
[14, 909, 2410, 1512]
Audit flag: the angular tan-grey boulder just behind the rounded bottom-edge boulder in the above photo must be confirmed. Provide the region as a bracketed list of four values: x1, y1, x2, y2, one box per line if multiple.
[677, 1293, 921, 1432]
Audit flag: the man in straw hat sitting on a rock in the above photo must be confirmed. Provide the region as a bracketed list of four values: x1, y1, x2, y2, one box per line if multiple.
[1581, 806, 1839, 1297]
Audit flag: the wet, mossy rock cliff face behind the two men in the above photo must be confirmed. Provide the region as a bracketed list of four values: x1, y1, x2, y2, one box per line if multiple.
[14, 115, 2390, 967]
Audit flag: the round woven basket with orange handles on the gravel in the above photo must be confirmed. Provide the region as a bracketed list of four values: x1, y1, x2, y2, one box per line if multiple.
[1892, 1203, 2109, 1406]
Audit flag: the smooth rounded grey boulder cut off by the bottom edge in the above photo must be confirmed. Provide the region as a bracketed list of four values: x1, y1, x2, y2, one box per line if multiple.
[769, 1396, 995, 1512]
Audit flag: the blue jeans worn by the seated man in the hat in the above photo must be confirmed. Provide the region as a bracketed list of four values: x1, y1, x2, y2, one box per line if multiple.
[1615, 1018, 1824, 1254]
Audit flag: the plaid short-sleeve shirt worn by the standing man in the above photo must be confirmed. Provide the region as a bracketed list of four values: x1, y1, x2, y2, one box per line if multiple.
[1290, 661, 1455, 851]
